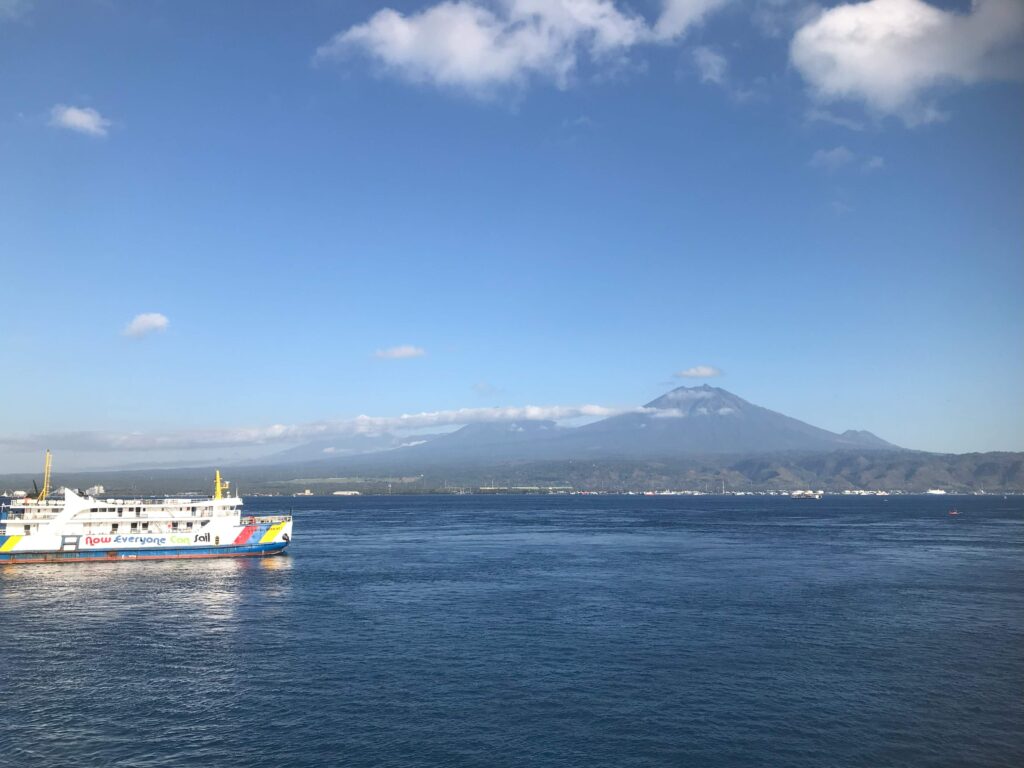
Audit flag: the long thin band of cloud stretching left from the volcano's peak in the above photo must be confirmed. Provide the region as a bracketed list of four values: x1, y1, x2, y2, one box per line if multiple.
[0, 404, 654, 451]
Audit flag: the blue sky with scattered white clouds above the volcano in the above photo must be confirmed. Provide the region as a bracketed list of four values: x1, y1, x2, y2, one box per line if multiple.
[0, 0, 1024, 471]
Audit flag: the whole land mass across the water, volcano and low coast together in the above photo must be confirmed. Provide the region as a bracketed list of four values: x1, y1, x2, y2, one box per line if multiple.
[0, 385, 1024, 495]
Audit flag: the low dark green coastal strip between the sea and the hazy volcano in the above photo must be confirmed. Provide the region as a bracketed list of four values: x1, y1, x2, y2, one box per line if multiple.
[0, 451, 1024, 497]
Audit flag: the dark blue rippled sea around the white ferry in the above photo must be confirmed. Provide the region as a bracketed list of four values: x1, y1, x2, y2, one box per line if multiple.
[0, 497, 1024, 768]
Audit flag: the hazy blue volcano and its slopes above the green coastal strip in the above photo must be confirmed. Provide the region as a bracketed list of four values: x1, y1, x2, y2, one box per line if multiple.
[112, 384, 901, 477]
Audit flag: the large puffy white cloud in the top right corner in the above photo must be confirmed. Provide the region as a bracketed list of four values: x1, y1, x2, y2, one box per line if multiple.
[790, 0, 1024, 125]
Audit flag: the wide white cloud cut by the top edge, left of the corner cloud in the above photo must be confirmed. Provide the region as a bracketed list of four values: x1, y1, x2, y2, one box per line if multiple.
[315, 0, 727, 96]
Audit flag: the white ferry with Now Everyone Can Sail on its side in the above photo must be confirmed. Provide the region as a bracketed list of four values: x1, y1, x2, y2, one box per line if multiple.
[0, 451, 292, 565]
